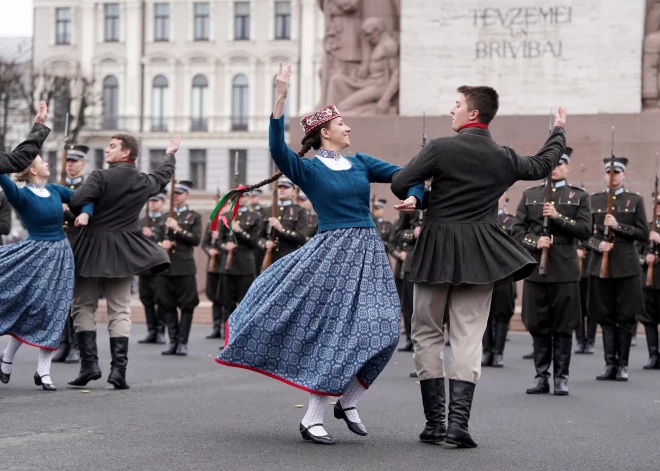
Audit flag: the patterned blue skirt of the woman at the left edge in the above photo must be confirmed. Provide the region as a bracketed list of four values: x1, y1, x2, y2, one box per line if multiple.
[0, 239, 75, 350]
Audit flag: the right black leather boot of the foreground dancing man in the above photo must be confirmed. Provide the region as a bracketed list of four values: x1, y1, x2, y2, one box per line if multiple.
[445, 379, 477, 448]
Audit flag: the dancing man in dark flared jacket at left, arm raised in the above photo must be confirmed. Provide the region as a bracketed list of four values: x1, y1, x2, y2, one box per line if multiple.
[69, 134, 180, 389]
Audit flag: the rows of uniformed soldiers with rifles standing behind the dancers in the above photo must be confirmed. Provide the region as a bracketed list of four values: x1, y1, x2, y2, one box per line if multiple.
[38, 146, 660, 395]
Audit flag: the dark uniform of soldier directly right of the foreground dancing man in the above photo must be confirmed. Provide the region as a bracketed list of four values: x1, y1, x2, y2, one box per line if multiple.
[512, 153, 591, 395]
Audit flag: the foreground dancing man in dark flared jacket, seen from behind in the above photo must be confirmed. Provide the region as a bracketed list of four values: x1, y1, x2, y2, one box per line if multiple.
[392, 86, 566, 448]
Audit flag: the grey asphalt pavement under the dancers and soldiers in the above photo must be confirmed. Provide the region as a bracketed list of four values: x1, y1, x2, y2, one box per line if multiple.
[0, 325, 660, 471]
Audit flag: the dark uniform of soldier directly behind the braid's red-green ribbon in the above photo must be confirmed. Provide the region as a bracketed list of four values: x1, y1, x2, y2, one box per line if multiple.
[218, 207, 263, 330]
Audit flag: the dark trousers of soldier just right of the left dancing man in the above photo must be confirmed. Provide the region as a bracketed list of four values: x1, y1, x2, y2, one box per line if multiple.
[156, 275, 199, 344]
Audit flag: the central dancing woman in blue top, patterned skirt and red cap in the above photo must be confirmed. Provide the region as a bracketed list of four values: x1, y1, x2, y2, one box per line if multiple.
[216, 64, 424, 444]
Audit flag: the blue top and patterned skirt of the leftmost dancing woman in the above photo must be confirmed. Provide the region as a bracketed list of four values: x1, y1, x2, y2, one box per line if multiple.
[0, 175, 93, 350]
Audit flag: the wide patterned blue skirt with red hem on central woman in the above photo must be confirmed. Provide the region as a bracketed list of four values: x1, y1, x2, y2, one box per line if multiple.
[216, 228, 400, 396]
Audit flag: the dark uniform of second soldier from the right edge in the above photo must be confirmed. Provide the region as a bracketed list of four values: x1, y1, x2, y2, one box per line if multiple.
[587, 157, 649, 381]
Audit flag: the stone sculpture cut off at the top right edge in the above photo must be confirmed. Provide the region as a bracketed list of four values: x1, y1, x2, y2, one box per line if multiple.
[642, 0, 660, 109]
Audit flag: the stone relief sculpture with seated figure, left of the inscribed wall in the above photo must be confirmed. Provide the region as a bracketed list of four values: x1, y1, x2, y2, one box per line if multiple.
[318, 0, 401, 115]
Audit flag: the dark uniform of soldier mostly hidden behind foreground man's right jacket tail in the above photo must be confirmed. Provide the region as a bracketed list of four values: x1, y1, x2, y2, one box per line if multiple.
[481, 209, 516, 367]
